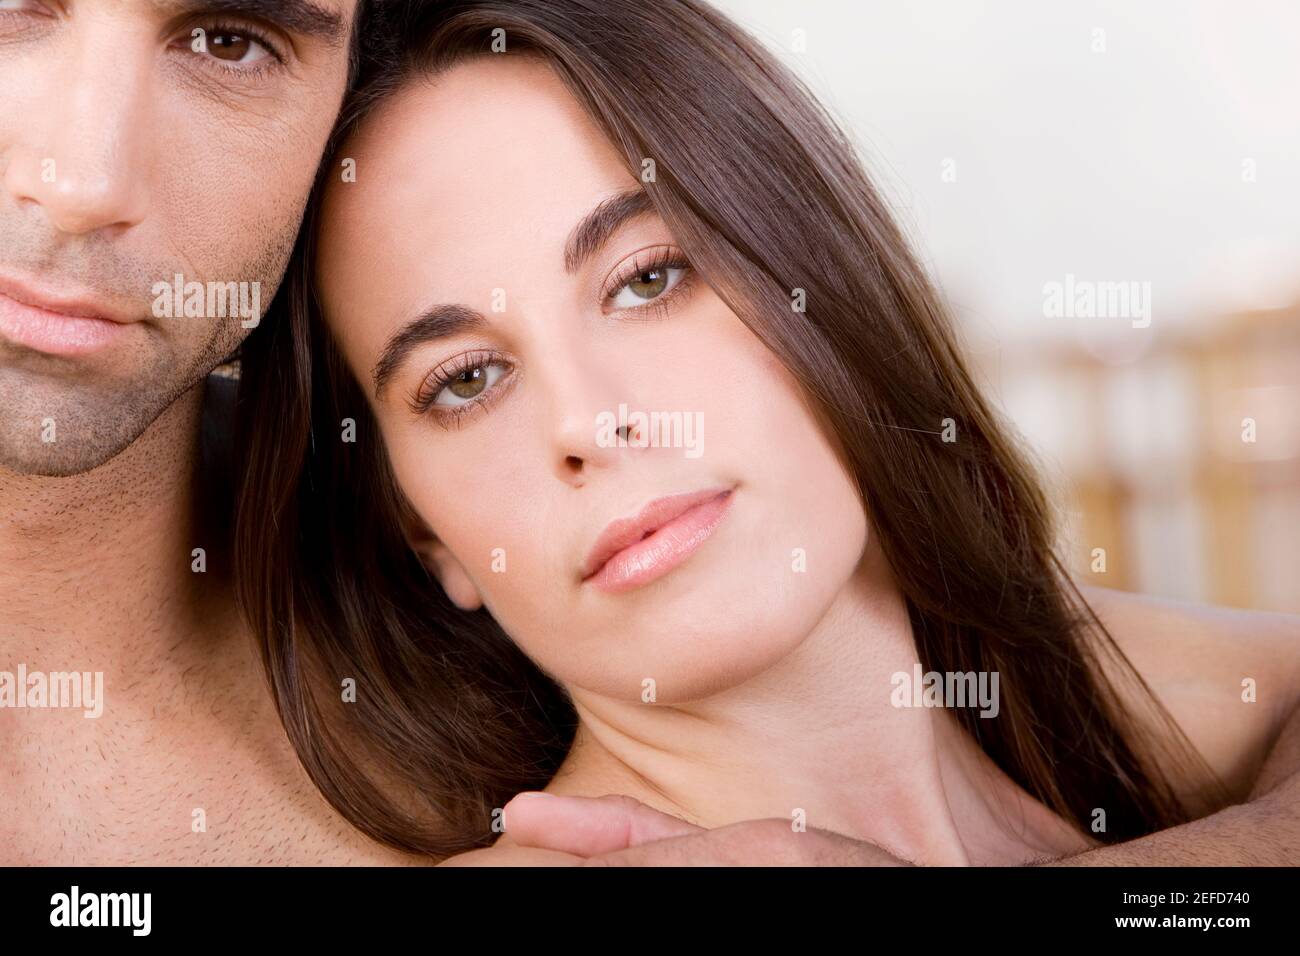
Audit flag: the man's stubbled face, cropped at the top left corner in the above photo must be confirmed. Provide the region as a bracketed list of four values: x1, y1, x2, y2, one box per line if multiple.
[0, 0, 356, 475]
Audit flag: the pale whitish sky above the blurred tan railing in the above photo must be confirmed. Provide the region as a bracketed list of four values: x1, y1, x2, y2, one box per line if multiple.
[715, 0, 1300, 347]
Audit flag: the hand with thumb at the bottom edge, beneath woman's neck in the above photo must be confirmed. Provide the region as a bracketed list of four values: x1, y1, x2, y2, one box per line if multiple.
[506, 793, 909, 866]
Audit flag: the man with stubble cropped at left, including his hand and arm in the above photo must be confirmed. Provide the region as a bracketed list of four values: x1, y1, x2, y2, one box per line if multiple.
[0, 0, 1297, 865]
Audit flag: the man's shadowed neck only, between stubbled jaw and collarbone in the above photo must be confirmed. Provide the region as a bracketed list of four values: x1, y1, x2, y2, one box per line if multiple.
[0, 382, 224, 671]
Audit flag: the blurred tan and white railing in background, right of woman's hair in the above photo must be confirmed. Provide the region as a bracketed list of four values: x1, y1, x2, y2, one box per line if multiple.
[978, 303, 1300, 613]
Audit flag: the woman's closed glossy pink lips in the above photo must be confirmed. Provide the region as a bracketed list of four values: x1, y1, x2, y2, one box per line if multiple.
[582, 488, 732, 593]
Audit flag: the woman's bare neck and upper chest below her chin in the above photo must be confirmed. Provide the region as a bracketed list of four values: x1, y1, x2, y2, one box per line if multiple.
[547, 554, 1089, 865]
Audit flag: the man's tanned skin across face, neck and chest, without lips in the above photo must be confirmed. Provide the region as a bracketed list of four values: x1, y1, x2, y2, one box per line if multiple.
[0, 0, 426, 865]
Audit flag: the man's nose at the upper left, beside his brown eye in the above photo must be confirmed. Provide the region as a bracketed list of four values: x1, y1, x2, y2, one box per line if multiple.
[4, 36, 155, 235]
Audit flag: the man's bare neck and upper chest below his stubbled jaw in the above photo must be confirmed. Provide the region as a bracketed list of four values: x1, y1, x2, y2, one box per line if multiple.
[0, 385, 436, 866]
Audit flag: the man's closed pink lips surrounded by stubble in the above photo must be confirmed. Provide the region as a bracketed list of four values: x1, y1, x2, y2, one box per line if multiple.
[0, 276, 133, 355]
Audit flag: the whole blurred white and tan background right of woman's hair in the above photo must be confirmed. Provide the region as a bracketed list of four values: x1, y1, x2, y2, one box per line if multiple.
[712, 0, 1300, 613]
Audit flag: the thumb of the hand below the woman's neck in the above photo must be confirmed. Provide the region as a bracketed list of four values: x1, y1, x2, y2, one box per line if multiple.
[504, 791, 701, 856]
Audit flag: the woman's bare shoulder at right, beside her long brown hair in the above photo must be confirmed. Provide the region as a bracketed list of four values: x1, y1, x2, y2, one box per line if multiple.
[1080, 587, 1300, 796]
